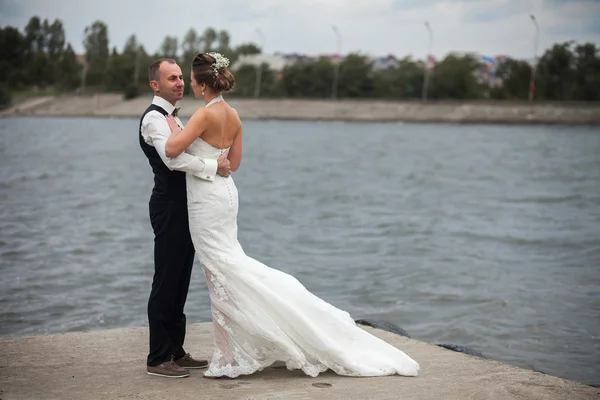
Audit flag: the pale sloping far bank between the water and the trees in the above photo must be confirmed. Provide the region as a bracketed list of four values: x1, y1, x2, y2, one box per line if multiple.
[0, 93, 600, 126]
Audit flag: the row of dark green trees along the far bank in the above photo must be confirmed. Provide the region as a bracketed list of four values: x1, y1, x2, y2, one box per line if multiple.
[0, 16, 600, 105]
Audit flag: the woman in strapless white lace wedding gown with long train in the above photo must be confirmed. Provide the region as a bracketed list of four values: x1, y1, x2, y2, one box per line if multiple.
[166, 53, 419, 378]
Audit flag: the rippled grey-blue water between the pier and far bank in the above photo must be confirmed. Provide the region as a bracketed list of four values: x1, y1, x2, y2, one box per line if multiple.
[0, 118, 600, 383]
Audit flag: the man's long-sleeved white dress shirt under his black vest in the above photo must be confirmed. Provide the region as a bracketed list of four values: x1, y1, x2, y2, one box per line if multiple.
[142, 96, 218, 181]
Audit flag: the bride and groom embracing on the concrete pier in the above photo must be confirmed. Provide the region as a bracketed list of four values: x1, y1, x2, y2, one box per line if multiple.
[139, 53, 419, 378]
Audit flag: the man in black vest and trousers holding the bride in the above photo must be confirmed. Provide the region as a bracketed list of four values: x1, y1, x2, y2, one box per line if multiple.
[139, 59, 230, 378]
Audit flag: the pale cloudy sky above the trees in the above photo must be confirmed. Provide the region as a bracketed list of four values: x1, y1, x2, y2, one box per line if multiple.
[0, 0, 600, 59]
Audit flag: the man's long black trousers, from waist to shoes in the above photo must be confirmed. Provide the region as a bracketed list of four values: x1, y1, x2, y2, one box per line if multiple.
[147, 198, 194, 366]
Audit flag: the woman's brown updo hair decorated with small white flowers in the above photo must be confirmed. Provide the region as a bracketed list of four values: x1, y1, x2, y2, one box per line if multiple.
[192, 53, 235, 92]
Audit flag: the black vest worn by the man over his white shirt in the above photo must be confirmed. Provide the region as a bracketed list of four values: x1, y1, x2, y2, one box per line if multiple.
[139, 104, 186, 201]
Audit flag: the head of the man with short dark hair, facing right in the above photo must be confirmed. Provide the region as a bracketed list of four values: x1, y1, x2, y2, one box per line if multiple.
[148, 58, 184, 105]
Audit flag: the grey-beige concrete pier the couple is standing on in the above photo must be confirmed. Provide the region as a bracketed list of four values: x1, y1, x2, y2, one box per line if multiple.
[0, 323, 600, 400]
